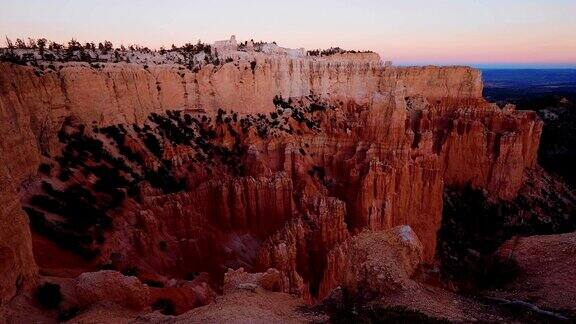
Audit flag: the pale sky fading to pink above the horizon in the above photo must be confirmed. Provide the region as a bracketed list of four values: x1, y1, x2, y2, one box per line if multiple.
[0, 0, 576, 67]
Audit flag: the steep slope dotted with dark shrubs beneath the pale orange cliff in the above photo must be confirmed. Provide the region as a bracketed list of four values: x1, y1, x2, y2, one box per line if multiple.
[25, 97, 333, 260]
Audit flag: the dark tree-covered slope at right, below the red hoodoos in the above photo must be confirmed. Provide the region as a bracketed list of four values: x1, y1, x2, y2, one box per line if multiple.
[438, 175, 576, 290]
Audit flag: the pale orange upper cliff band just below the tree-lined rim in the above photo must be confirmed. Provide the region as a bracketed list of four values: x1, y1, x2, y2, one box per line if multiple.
[0, 56, 482, 184]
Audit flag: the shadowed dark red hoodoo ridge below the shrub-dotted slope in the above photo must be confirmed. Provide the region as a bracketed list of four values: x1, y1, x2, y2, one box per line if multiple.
[102, 175, 294, 277]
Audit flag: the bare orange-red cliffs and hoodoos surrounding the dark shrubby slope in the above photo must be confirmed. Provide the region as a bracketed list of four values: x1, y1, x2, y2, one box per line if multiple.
[0, 49, 541, 308]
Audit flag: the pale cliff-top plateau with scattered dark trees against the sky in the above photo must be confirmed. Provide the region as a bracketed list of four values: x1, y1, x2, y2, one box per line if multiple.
[0, 36, 391, 72]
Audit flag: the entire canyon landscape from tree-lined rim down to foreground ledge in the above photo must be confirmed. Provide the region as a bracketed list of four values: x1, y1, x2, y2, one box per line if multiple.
[0, 38, 576, 323]
